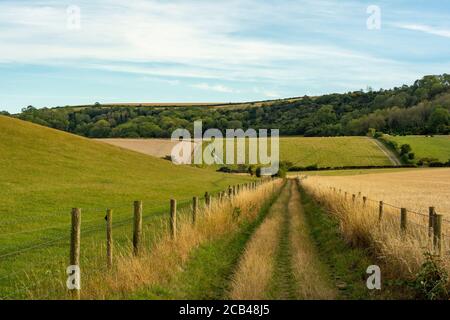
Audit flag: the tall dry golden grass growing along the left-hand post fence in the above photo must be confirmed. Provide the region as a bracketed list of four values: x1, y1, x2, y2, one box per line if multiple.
[82, 180, 282, 299]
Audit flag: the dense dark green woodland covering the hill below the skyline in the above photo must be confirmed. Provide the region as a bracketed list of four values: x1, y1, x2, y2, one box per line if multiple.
[6, 74, 450, 138]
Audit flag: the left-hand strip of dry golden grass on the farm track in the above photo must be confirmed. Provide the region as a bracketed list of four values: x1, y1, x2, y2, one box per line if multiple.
[229, 182, 289, 300]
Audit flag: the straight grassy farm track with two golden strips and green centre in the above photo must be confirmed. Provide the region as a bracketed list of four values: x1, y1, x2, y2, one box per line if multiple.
[230, 180, 336, 300]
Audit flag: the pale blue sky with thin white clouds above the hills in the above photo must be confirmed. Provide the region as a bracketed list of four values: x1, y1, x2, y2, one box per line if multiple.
[0, 0, 450, 112]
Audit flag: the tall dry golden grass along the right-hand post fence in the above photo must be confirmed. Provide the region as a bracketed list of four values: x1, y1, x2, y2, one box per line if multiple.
[302, 177, 450, 278]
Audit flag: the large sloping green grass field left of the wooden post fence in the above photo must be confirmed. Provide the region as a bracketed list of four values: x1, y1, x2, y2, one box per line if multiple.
[0, 116, 250, 299]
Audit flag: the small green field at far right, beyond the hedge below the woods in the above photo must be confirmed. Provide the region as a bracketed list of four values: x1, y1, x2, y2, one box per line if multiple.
[389, 136, 450, 162]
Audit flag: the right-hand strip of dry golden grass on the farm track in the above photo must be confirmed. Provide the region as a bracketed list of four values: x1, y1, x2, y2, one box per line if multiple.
[288, 183, 336, 300]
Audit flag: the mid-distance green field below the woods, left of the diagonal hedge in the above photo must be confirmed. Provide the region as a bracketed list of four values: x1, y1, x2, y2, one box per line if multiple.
[201, 137, 392, 167]
